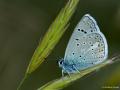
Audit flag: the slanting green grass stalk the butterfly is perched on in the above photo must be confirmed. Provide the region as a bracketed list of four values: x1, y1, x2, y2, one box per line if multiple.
[37, 60, 113, 90]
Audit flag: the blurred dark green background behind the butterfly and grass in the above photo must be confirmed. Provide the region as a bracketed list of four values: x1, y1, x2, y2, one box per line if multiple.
[0, 0, 120, 90]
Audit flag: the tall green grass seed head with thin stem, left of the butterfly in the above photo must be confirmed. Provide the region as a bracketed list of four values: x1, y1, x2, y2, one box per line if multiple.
[17, 0, 79, 90]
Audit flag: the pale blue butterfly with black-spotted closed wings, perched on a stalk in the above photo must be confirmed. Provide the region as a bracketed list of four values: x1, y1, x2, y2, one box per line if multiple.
[58, 14, 108, 75]
